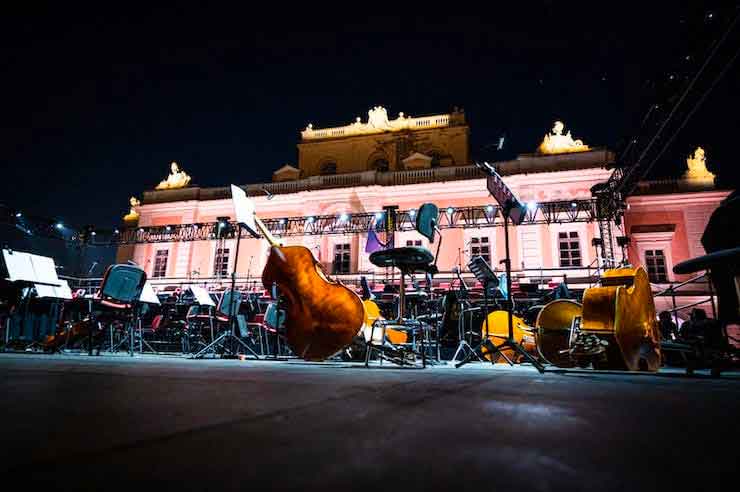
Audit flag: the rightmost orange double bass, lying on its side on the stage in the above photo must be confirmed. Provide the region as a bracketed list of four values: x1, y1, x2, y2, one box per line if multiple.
[581, 267, 660, 371]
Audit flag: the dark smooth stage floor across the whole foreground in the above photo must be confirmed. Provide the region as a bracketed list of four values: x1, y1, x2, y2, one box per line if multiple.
[0, 354, 740, 491]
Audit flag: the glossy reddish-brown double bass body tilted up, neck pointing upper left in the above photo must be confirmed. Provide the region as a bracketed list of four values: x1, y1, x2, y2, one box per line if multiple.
[262, 245, 365, 360]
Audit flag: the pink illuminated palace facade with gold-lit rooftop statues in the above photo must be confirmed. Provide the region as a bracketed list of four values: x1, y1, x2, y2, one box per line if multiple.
[119, 107, 729, 316]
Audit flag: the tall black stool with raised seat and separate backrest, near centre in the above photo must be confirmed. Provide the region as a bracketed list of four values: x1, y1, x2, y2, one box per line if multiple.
[365, 203, 442, 367]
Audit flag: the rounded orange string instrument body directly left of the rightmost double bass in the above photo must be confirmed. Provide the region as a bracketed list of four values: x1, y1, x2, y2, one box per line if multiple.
[535, 299, 583, 367]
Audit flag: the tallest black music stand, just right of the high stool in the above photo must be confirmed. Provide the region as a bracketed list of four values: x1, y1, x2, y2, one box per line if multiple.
[455, 163, 545, 373]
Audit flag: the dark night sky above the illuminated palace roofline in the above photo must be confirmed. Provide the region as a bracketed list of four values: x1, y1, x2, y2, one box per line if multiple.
[0, 1, 740, 234]
